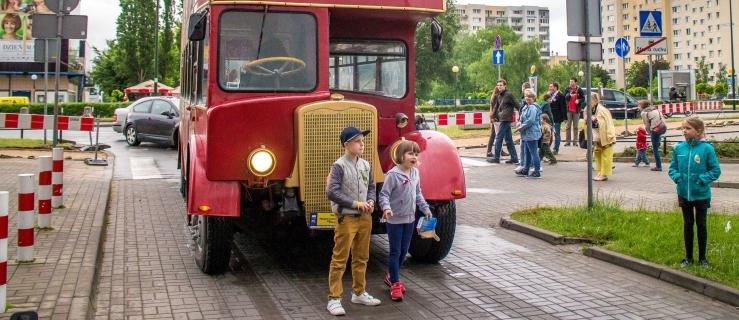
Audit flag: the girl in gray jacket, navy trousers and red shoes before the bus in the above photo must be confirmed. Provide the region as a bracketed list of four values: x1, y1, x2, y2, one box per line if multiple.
[380, 140, 431, 301]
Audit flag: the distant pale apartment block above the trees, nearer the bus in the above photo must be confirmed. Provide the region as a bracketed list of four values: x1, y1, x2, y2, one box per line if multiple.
[456, 4, 550, 59]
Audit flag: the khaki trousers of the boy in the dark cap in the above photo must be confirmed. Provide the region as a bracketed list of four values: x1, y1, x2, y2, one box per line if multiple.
[328, 214, 372, 299]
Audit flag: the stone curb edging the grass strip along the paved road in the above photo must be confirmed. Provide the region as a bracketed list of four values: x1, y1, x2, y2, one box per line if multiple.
[500, 217, 739, 308]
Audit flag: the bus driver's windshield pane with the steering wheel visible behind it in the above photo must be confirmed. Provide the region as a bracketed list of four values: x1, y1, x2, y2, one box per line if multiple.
[218, 10, 317, 92]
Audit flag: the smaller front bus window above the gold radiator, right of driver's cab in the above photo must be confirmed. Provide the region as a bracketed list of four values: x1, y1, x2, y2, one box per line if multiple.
[329, 40, 408, 98]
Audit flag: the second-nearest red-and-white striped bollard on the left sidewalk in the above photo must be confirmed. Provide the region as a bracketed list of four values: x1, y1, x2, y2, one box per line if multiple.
[16, 174, 35, 262]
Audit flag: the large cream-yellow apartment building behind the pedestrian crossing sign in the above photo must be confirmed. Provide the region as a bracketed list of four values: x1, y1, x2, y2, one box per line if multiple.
[601, 0, 739, 87]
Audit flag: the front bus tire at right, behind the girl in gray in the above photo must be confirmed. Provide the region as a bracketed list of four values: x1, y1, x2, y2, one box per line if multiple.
[408, 200, 457, 263]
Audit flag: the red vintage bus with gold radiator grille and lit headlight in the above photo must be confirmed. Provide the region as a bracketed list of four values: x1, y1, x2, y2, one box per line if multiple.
[179, 0, 466, 274]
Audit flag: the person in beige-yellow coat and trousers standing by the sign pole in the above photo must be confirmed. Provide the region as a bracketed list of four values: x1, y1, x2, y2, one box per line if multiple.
[590, 92, 616, 181]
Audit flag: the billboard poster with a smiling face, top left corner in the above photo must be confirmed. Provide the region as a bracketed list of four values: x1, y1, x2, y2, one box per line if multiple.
[0, 0, 54, 62]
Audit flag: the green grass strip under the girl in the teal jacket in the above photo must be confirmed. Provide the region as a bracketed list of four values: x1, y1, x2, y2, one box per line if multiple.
[512, 201, 739, 289]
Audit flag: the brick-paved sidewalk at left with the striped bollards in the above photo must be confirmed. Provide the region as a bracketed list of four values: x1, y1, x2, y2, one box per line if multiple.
[0, 152, 113, 319]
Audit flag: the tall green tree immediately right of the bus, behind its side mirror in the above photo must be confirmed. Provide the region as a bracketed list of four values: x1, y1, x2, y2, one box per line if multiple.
[415, 0, 460, 99]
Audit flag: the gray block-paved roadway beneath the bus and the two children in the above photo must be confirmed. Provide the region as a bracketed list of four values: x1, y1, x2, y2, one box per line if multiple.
[95, 174, 739, 319]
